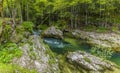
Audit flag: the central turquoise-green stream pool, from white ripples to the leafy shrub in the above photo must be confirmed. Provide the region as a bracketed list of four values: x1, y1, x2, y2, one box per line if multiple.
[44, 38, 90, 54]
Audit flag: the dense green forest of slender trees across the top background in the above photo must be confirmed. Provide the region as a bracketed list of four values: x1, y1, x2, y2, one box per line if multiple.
[3, 0, 120, 28]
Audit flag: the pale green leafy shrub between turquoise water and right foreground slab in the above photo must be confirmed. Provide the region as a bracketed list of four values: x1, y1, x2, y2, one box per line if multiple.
[91, 47, 114, 59]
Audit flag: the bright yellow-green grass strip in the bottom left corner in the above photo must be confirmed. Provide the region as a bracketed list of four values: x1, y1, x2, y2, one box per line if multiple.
[0, 63, 38, 73]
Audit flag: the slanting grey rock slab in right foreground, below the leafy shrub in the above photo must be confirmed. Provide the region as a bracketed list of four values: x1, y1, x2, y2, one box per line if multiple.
[67, 51, 116, 73]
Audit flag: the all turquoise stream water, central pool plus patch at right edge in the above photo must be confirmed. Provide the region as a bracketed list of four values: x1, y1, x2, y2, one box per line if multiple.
[44, 38, 120, 66]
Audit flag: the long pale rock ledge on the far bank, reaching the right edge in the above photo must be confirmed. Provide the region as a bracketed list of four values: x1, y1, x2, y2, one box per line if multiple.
[72, 30, 120, 52]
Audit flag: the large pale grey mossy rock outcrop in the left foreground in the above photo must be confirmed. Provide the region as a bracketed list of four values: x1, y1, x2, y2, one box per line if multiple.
[13, 35, 59, 73]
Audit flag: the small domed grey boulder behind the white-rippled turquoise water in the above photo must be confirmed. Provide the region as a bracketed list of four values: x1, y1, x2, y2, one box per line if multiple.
[43, 26, 63, 39]
